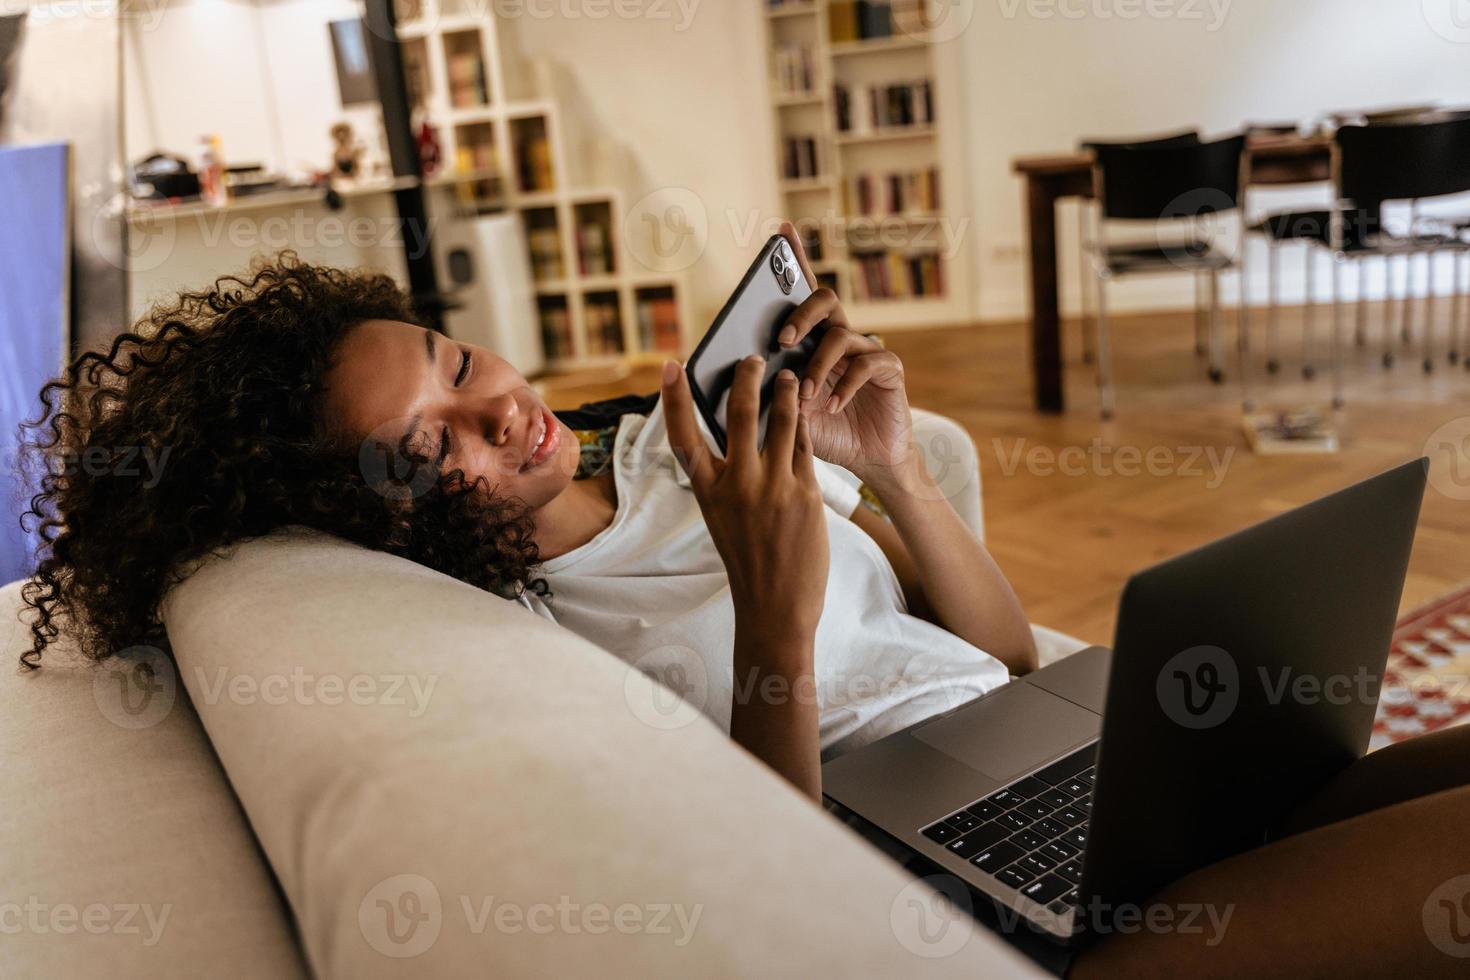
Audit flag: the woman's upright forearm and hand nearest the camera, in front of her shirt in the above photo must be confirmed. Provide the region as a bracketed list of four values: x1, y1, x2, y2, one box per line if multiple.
[663, 357, 828, 801]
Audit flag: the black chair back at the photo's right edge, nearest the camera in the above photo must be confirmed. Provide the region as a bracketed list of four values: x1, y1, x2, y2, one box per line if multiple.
[1338, 113, 1470, 207]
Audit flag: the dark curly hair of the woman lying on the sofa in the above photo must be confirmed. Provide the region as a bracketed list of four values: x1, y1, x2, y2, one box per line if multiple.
[21, 253, 545, 669]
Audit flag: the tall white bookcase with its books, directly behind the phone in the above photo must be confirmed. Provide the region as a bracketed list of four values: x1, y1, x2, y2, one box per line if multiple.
[756, 0, 973, 329]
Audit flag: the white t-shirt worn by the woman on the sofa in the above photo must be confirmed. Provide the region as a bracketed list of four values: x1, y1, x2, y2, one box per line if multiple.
[522, 401, 1008, 758]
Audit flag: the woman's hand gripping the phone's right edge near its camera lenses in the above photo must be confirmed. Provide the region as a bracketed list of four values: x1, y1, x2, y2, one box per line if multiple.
[776, 222, 914, 491]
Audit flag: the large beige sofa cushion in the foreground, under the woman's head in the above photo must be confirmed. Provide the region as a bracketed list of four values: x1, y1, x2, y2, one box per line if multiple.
[165, 532, 1030, 977]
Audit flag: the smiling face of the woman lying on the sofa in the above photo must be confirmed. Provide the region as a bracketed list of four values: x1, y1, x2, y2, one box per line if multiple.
[326, 320, 581, 510]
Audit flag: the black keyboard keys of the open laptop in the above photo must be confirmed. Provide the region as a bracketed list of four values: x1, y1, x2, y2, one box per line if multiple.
[920, 742, 1098, 915]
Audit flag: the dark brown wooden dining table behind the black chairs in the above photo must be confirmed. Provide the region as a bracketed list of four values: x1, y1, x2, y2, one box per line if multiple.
[1011, 134, 1333, 413]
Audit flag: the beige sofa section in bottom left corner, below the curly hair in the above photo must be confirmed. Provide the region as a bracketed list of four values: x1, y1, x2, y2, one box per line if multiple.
[0, 583, 306, 979]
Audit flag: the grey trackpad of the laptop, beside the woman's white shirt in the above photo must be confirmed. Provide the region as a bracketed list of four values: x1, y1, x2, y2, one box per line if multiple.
[913, 682, 1103, 782]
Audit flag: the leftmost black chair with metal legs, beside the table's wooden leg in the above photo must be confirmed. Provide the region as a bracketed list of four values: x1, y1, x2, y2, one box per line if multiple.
[1092, 135, 1250, 419]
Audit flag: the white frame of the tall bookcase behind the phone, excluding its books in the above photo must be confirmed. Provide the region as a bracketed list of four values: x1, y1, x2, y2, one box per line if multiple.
[754, 0, 973, 329]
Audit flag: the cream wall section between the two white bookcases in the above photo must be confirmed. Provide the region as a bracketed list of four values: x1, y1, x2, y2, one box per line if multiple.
[500, 0, 781, 332]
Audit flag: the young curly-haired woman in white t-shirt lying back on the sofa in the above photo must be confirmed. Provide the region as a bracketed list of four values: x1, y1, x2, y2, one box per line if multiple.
[22, 226, 1470, 976]
